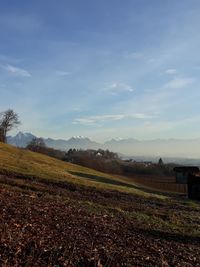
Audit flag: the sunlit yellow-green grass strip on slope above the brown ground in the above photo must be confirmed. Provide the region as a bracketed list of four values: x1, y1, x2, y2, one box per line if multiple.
[0, 143, 166, 198]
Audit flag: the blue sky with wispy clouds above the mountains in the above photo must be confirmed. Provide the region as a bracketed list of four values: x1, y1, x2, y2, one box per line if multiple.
[0, 0, 200, 141]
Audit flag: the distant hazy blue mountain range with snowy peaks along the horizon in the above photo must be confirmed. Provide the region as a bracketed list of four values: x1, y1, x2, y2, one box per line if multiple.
[7, 132, 200, 161]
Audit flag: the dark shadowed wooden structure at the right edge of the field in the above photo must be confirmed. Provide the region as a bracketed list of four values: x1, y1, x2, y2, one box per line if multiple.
[174, 166, 200, 200]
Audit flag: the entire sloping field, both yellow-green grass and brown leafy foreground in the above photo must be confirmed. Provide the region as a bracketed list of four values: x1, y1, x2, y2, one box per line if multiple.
[0, 143, 200, 267]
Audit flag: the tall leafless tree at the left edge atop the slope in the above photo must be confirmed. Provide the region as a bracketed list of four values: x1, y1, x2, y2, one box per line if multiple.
[0, 109, 20, 143]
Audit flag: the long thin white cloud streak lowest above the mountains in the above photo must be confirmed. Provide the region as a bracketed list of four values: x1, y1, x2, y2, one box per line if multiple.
[73, 113, 154, 125]
